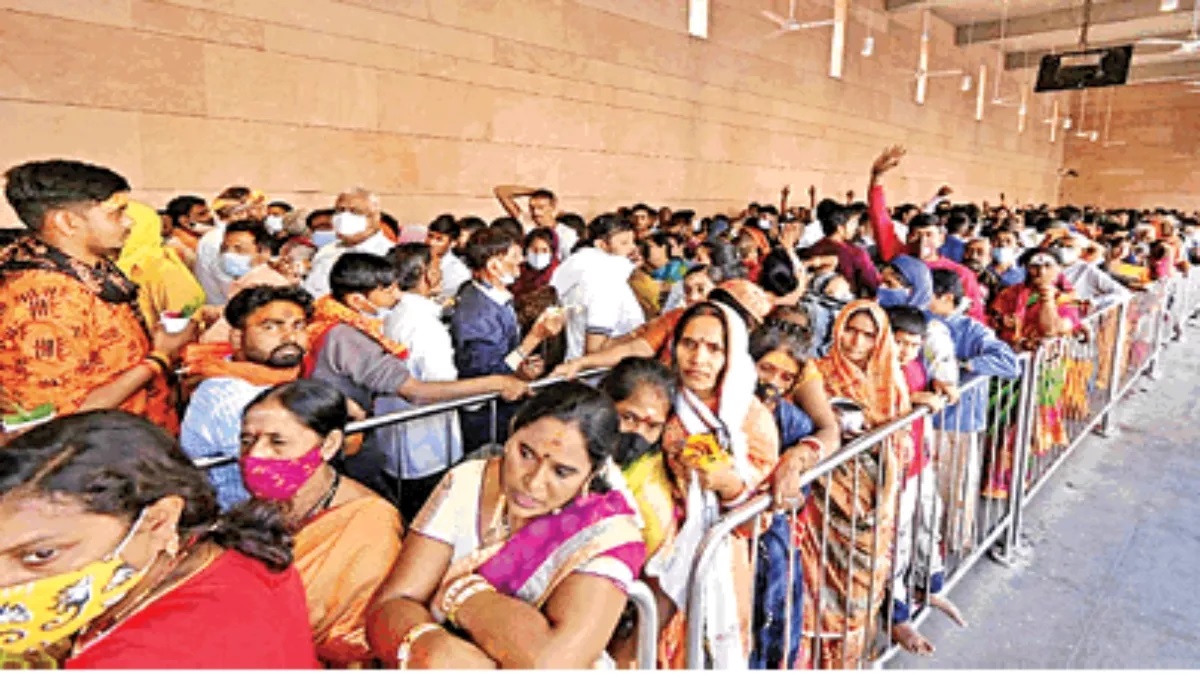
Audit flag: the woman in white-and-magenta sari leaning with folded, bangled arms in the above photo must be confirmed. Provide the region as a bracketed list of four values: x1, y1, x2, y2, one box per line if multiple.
[367, 382, 646, 669]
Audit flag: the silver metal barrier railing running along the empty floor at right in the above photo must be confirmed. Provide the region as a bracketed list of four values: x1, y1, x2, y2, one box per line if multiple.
[686, 273, 1200, 669]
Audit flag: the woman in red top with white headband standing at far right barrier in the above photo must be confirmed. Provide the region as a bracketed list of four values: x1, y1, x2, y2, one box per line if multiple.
[983, 249, 1081, 500]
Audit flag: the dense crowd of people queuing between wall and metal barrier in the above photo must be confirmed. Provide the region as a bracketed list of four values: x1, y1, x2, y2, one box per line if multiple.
[0, 148, 1200, 669]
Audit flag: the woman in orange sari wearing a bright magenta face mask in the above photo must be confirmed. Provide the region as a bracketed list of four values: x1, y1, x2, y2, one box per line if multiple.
[241, 380, 401, 668]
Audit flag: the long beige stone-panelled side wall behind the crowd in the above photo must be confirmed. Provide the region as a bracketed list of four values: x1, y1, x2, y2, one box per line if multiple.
[0, 0, 1062, 223]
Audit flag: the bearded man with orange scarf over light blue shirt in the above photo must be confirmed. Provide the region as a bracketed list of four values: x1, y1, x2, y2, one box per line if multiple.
[180, 286, 312, 509]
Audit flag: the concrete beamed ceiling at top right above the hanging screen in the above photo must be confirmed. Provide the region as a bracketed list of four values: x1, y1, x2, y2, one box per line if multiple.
[884, 0, 1200, 84]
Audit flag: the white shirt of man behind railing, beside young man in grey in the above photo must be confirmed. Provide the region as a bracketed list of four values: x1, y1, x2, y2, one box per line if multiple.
[374, 292, 462, 479]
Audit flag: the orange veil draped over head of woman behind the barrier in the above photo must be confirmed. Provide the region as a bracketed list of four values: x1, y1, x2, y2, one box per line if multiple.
[817, 300, 912, 426]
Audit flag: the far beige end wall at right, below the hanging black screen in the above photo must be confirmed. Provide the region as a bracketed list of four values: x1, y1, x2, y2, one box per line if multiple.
[1062, 83, 1200, 210]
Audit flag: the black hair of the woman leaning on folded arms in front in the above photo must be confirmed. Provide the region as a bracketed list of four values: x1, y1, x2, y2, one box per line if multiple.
[510, 382, 620, 494]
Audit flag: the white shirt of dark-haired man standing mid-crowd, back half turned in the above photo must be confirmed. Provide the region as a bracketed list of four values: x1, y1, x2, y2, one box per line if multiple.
[550, 241, 646, 359]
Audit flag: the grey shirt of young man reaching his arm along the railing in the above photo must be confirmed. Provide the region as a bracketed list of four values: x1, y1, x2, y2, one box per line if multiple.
[312, 324, 409, 411]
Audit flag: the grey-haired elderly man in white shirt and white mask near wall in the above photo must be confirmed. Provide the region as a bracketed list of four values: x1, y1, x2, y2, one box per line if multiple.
[304, 187, 392, 298]
